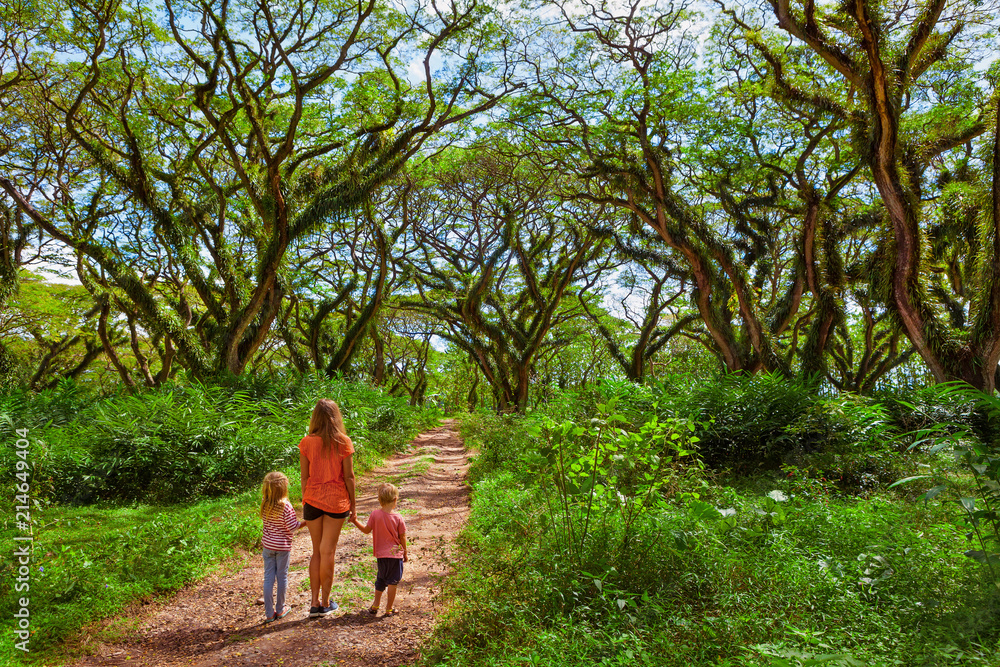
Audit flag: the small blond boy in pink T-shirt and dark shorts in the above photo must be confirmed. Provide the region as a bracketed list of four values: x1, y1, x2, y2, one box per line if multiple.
[352, 484, 408, 616]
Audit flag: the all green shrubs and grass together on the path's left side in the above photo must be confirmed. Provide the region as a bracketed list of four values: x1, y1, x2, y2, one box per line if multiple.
[0, 376, 438, 664]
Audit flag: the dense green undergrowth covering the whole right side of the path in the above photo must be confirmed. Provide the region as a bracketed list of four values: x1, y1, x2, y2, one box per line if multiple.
[426, 376, 1000, 666]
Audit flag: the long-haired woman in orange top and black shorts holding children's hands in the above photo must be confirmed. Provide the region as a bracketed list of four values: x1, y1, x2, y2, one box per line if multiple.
[299, 398, 357, 617]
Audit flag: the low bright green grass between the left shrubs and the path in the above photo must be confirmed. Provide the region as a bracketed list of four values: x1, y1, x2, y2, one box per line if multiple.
[0, 482, 260, 662]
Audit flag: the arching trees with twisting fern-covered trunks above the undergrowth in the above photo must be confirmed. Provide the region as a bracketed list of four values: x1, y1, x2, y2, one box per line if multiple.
[0, 0, 1000, 411]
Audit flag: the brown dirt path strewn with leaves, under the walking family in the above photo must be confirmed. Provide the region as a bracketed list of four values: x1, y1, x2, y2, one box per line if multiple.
[74, 422, 469, 667]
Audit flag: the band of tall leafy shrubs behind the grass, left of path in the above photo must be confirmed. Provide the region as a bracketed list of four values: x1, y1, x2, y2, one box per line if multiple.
[0, 374, 424, 503]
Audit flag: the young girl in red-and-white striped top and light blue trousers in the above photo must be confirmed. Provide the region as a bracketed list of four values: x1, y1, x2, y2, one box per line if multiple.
[260, 472, 306, 623]
